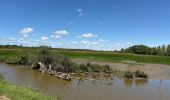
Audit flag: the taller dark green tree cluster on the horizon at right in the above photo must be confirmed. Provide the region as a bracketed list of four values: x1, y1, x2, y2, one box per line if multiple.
[119, 45, 170, 56]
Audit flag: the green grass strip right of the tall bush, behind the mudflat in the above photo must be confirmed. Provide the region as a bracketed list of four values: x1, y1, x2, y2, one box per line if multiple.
[61, 51, 170, 65]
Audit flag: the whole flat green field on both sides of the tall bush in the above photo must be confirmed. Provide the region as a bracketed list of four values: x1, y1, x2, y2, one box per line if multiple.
[0, 49, 170, 65]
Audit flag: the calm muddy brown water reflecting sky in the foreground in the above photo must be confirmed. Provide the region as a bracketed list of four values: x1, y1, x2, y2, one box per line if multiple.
[0, 63, 170, 100]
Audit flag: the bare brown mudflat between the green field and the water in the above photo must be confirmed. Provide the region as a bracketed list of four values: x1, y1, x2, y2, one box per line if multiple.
[72, 59, 170, 80]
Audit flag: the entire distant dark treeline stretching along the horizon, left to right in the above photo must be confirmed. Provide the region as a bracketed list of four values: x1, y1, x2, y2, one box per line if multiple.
[0, 44, 170, 56]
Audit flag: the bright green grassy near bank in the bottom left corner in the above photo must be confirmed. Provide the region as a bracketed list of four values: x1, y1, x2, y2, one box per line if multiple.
[0, 73, 57, 100]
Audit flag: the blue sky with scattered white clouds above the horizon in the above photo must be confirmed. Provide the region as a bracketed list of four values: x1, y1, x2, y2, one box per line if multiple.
[0, 0, 170, 50]
